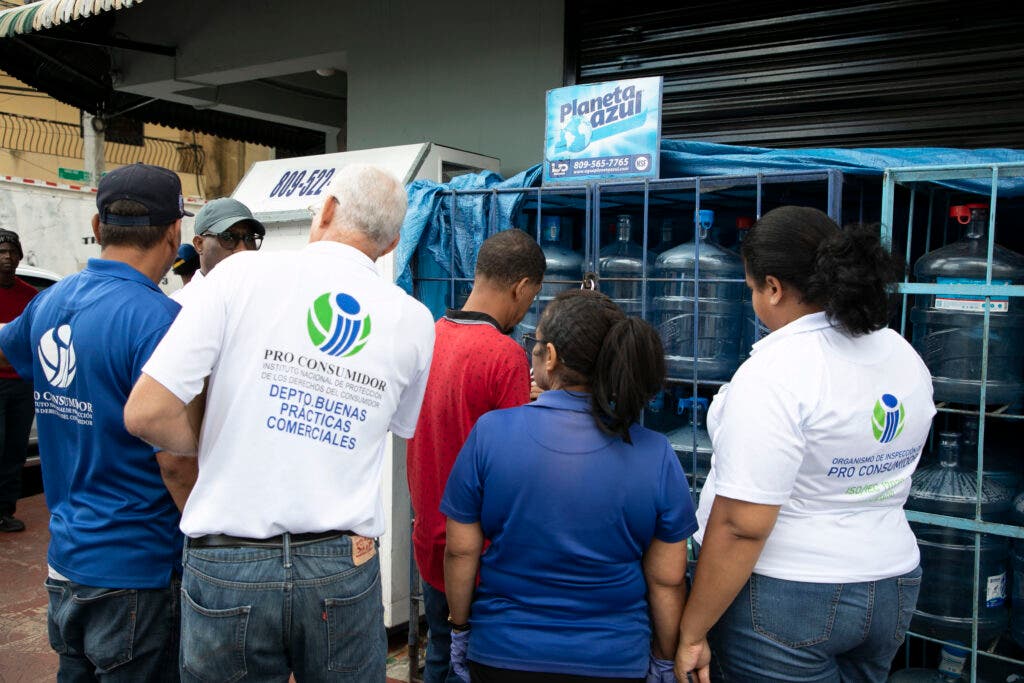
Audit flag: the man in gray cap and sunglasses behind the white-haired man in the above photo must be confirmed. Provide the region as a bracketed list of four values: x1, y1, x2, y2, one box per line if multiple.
[171, 197, 266, 305]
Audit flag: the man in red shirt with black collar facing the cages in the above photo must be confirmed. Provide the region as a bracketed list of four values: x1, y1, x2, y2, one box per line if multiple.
[408, 229, 545, 683]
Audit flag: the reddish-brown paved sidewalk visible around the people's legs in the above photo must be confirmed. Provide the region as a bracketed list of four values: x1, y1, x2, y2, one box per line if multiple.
[0, 494, 422, 683]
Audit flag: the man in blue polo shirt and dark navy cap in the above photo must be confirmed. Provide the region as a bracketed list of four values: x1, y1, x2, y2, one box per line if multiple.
[0, 164, 196, 681]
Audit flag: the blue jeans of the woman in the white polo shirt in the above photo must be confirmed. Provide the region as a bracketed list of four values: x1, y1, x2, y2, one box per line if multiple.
[709, 567, 921, 683]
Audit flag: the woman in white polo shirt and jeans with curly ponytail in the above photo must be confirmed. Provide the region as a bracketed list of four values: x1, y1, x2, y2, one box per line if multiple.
[676, 207, 935, 681]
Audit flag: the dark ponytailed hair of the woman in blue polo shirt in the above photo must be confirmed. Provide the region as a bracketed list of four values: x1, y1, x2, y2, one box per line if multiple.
[538, 290, 665, 443]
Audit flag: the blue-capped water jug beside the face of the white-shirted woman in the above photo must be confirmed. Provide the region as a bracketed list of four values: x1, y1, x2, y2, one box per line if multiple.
[651, 210, 746, 380]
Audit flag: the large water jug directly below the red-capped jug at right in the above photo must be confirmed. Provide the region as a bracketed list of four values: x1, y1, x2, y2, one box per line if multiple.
[906, 432, 1013, 645]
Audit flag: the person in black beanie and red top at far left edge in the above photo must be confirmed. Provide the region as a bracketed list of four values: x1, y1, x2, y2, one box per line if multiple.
[0, 229, 37, 531]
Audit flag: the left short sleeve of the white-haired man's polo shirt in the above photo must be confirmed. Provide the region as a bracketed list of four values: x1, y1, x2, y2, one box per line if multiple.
[142, 260, 234, 403]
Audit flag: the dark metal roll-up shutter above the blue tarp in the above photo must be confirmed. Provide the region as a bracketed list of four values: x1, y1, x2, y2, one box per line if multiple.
[565, 0, 1024, 148]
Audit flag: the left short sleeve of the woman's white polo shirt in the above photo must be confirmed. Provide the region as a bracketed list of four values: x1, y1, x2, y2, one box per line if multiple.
[708, 367, 806, 505]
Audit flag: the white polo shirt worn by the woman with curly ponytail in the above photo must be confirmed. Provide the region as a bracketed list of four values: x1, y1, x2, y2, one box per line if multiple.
[695, 313, 935, 583]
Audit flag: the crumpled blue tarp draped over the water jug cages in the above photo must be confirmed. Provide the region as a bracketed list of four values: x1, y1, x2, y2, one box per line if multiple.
[395, 140, 1024, 292]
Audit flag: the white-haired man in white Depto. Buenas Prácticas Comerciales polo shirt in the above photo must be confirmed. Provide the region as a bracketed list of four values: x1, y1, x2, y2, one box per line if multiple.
[125, 166, 434, 683]
